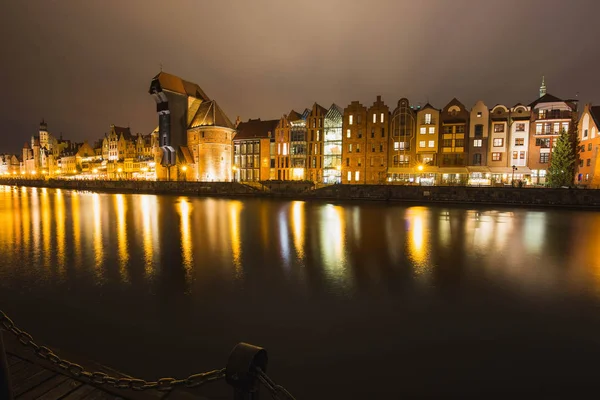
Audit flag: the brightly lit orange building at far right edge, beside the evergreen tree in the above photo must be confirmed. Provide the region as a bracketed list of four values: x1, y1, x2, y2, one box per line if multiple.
[575, 104, 600, 185]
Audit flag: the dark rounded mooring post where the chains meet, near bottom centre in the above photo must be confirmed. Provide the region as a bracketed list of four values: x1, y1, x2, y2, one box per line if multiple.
[225, 343, 268, 400]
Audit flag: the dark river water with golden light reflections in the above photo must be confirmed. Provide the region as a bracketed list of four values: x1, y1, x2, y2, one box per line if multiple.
[0, 186, 600, 399]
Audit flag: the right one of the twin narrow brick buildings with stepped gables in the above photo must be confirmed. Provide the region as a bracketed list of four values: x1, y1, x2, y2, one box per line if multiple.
[364, 96, 392, 185]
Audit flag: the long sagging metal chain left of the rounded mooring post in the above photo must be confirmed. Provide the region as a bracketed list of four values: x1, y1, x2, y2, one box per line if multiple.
[0, 310, 225, 391]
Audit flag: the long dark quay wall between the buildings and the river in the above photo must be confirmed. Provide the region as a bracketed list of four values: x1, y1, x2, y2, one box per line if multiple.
[0, 179, 600, 209]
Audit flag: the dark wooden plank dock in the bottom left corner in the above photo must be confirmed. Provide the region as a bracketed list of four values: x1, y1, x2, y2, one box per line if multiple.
[2, 335, 213, 400]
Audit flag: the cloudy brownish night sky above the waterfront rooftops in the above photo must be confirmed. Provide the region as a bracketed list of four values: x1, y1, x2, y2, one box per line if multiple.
[0, 0, 600, 152]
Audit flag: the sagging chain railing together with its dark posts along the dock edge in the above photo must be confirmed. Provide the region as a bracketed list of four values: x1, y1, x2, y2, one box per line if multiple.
[0, 311, 294, 400]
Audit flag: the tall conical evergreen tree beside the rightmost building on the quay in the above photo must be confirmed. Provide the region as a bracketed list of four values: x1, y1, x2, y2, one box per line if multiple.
[547, 116, 579, 188]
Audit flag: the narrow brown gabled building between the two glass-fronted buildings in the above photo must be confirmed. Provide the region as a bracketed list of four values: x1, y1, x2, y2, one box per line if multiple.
[306, 103, 327, 183]
